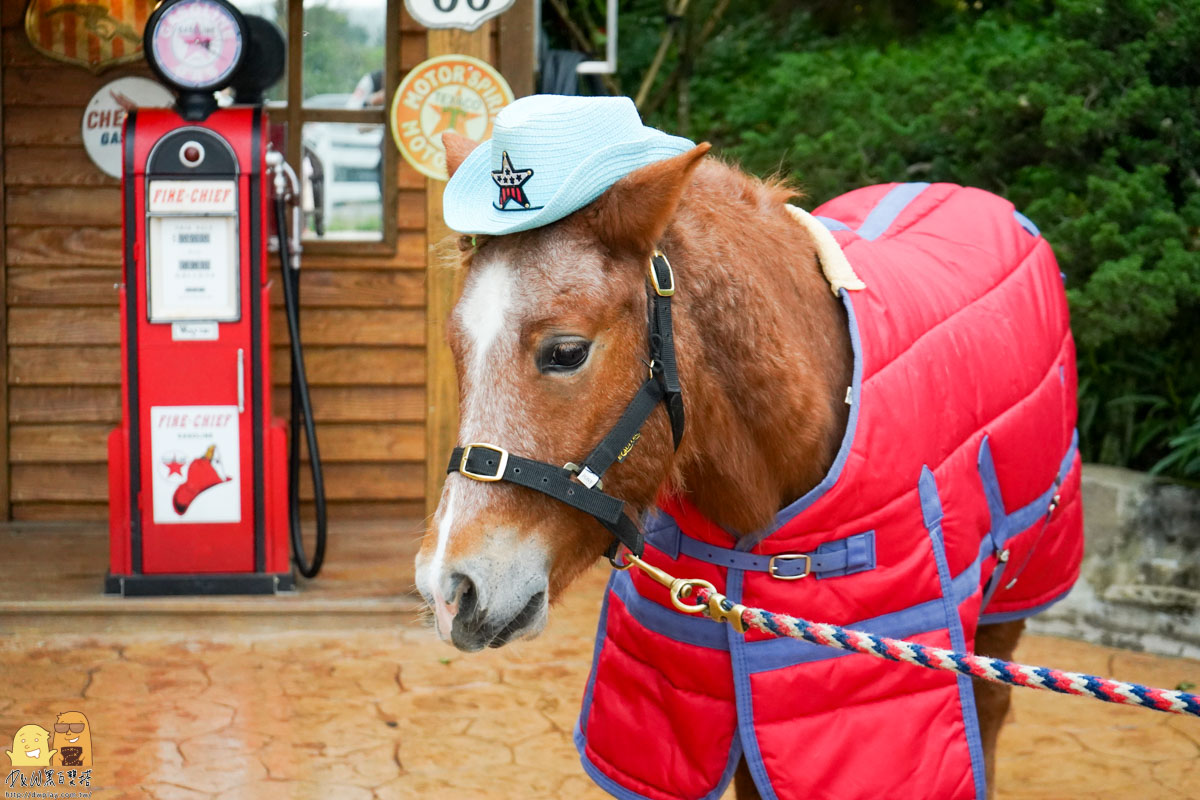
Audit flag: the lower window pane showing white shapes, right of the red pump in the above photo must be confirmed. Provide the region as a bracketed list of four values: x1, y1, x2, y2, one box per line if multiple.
[301, 122, 384, 241]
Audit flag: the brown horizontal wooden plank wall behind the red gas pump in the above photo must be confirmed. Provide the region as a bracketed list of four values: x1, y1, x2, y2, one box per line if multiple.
[0, 0, 440, 522]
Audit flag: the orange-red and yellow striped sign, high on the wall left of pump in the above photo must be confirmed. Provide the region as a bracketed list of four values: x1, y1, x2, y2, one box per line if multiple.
[25, 0, 155, 72]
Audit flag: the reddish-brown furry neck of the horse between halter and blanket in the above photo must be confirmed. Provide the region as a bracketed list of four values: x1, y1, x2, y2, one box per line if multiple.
[661, 158, 853, 534]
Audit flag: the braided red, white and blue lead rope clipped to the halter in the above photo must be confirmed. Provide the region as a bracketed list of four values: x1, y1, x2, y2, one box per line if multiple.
[694, 587, 1200, 717]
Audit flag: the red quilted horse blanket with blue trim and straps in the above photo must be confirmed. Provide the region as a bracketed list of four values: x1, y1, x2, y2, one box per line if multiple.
[575, 184, 1082, 800]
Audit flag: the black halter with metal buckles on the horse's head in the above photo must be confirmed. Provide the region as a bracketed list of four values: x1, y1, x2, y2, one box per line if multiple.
[446, 251, 684, 558]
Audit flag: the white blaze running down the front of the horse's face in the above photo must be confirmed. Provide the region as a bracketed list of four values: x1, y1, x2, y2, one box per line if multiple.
[418, 263, 517, 637]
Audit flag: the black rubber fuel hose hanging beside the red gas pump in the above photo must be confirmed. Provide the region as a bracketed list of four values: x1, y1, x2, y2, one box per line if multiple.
[275, 194, 326, 578]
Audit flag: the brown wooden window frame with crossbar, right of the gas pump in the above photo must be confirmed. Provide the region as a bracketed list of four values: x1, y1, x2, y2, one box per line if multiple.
[268, 0, 403, 255]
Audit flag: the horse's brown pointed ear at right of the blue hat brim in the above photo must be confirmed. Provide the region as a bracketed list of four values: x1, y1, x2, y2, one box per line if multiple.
[592, 142, 713, 255]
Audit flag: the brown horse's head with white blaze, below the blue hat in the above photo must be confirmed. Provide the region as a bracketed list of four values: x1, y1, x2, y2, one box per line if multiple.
[416, 134, 708, 650]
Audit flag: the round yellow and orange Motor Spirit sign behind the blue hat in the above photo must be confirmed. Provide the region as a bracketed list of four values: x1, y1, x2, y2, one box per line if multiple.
[390, 55, 512, 181]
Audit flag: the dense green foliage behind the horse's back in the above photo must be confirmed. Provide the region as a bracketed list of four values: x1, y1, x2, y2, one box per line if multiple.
[622, 0, 1200, 480]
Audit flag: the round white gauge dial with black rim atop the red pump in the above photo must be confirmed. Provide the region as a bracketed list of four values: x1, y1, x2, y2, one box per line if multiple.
[145, 0, 247, 92]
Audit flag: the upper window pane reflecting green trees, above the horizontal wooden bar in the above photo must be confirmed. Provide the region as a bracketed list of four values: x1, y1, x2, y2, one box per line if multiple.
[304, 0, 388, 108]
